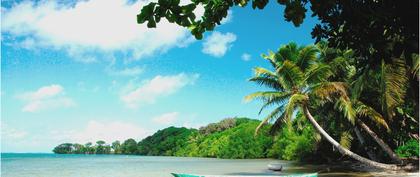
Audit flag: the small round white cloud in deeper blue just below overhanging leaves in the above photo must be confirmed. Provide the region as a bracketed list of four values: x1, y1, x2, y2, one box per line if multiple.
[202, 31, 236, 57]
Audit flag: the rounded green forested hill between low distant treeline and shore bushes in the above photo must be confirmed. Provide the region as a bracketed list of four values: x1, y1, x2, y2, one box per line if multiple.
[138, 118, 272, 158]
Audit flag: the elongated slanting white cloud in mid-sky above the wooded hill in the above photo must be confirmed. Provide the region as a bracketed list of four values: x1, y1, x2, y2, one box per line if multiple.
[120, 73, 199, 108]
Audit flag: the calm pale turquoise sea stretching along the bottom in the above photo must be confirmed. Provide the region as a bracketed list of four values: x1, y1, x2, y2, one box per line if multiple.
[1, 153, 418, 177]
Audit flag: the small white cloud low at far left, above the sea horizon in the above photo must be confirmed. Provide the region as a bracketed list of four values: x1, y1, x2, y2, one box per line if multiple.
[17, 84, 76, 112]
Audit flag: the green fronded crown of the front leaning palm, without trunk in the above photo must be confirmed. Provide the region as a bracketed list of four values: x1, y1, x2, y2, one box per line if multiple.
[245, 42, 340, 134]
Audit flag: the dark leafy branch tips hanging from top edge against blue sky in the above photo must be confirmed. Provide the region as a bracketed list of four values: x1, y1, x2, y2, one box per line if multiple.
[137, 0, 307, 39]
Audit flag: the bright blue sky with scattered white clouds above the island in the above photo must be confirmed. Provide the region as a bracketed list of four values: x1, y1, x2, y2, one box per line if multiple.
[0, 0, 317, 152]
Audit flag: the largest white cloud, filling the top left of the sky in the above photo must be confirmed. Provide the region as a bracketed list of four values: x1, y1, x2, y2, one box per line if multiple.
[1, 0, 194, 62]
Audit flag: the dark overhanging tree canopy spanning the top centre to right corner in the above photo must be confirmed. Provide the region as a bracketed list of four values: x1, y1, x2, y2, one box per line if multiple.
[137, 0, 419, 69]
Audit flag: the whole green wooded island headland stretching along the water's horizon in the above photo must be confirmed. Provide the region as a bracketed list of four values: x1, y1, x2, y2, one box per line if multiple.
[53, 118, 315, 160]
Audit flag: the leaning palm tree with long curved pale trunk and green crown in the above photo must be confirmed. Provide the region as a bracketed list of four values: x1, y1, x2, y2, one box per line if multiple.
[245, 43, 398, 169]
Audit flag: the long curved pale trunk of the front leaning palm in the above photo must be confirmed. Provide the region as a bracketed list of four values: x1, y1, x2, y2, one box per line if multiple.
[303, 106, 400, 170]
